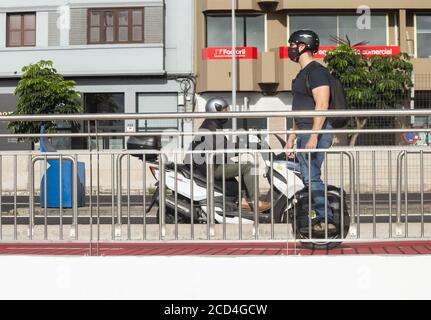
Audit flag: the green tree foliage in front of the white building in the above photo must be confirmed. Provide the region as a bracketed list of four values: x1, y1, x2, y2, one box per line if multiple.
[8, 60, 82, 142]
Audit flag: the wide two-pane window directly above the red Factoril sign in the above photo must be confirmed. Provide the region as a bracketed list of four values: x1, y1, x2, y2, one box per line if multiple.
[207, 15, 265, 52]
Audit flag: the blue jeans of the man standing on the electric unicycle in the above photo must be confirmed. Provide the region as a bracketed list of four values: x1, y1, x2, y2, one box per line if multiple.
[297, 124, 334, 223]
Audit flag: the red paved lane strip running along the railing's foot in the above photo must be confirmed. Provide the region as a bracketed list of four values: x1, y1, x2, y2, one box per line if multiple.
[0, 241, 431, 256]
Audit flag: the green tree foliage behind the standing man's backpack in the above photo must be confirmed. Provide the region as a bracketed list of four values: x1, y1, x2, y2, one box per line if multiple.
[324, 43, 413, 145]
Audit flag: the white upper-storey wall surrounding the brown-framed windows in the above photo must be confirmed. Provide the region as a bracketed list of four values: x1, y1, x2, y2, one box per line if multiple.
[0, 0, 194, 77]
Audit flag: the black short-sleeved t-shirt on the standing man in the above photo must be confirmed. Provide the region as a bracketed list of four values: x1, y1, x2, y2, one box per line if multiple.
[292, 61, 330, 130]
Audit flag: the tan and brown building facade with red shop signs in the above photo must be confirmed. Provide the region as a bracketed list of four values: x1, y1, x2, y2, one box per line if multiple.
[195, 0, 431, 143]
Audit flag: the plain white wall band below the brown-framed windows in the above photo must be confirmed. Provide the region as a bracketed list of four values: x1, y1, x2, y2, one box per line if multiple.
[0, 45, 164, 77]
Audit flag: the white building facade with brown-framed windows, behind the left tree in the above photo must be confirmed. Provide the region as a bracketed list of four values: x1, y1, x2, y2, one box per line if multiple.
[0, 0, 194, 150]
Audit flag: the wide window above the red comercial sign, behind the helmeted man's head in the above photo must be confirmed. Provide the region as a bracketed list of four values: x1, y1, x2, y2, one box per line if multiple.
[290, 14, 387, 46]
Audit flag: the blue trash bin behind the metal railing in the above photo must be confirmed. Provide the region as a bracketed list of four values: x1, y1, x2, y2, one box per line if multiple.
[40, 127, 85, 208]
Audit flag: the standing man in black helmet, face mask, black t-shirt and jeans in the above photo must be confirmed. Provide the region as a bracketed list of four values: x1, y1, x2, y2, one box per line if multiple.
[286, 30, 336, 232]
